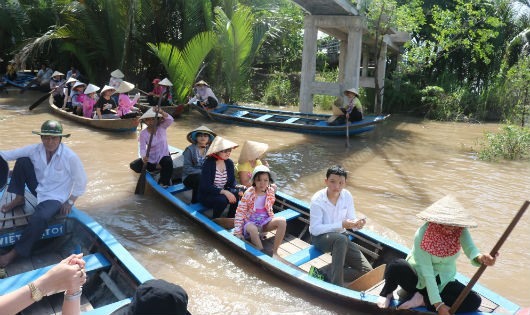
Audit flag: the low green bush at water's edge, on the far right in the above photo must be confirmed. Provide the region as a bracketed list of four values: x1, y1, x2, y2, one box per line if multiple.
[478, 125, 530, 161]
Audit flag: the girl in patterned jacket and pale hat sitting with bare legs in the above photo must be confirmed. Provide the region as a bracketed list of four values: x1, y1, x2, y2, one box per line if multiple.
[234, 165, 287, 258]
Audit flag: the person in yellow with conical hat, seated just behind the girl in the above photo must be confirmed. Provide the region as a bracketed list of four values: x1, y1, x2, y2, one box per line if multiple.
[236, 140, 269, 188]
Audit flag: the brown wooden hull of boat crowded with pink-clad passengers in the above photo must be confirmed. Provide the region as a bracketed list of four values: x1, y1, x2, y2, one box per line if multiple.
[49, 95, 139, 132]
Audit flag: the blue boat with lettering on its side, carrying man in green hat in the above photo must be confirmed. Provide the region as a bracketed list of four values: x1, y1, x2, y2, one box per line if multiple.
[0, 178, 153, 315]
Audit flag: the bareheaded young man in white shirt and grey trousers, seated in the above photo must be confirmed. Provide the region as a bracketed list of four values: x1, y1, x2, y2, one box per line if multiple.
[309, 165, 372, 286]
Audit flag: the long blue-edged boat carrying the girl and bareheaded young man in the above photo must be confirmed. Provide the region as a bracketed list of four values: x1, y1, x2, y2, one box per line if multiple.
[141, 146, 520, 315]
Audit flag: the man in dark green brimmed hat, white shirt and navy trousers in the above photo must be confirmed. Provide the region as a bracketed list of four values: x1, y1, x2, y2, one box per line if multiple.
[0, 120, 87, 267]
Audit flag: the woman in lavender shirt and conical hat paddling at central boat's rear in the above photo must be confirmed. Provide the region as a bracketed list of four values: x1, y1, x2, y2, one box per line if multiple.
[138, 107, 173, 187]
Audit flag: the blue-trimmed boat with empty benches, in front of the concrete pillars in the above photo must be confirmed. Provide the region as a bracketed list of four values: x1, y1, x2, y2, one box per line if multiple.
[190, 104, 388, 136]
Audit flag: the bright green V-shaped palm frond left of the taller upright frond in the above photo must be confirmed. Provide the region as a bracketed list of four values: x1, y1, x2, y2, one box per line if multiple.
[148, 32, 216, 103]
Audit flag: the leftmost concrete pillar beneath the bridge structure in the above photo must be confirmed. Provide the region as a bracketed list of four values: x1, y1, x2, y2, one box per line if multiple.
[300, 15, 318, 113]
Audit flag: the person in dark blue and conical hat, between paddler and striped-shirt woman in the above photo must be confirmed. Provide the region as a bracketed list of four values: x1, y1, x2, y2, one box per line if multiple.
[182, 126, 216, 203]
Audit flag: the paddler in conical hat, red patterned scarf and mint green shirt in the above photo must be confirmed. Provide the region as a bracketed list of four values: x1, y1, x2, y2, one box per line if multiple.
[378, 195, 496, 314]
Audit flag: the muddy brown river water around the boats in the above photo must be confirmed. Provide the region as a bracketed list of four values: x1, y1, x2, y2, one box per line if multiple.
[0, 91, 530, 314]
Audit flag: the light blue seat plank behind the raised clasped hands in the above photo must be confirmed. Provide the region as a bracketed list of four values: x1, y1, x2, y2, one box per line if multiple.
[0, 253, 111, 295]
